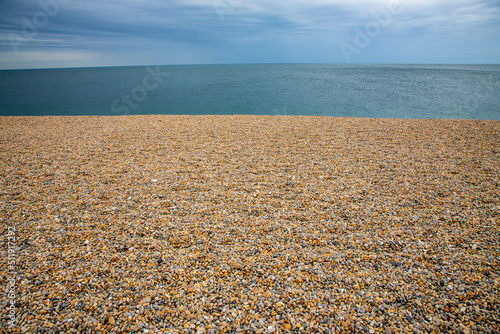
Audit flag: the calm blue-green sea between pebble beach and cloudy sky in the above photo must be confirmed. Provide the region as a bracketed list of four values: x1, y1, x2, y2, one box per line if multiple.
[0, 64, 500, 120]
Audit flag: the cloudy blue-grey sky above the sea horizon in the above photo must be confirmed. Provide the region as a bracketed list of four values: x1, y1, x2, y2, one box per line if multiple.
[0, 0, 500, 69]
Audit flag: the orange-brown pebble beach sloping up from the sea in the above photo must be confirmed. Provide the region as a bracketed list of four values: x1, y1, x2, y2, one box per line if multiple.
[0, 115, 500, 334]
